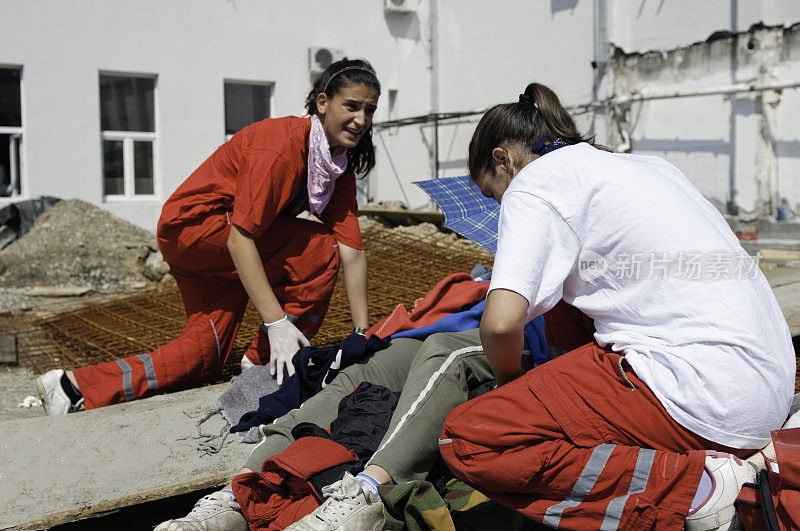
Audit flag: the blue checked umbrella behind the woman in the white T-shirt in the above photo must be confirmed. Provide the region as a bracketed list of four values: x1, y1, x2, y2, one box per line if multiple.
[414, 175, 500, 254]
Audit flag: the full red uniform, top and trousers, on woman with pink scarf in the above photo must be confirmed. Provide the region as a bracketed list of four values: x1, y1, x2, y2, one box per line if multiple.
[74, 117, 364, 409]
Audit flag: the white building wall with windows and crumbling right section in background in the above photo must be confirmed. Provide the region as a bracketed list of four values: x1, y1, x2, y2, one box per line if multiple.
[0, 0, 800, 230]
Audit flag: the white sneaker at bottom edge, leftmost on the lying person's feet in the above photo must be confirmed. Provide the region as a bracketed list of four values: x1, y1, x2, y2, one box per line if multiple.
[155, 491, 247, 531]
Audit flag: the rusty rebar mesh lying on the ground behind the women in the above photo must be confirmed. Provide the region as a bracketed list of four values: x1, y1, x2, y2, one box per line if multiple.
[0, 224, 493, 381]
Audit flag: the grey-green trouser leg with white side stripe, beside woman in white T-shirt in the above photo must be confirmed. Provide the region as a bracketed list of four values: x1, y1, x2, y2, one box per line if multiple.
[365, 329, 493, 483]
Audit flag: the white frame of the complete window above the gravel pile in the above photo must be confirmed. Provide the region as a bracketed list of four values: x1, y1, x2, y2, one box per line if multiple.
[97, 70, 161, 203]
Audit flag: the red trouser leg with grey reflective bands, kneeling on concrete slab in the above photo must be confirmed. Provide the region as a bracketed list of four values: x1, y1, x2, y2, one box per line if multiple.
[65, 215, 252, 408]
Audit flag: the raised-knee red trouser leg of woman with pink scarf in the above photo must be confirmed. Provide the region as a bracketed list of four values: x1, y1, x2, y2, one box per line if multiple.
[238, 216, 339, 365]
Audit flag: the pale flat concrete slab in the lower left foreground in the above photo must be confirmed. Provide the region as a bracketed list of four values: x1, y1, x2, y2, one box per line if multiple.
[0, 383, 252, 529]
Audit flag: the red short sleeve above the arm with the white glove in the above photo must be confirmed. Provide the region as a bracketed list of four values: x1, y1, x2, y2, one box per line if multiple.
[231, 134, 302, 238]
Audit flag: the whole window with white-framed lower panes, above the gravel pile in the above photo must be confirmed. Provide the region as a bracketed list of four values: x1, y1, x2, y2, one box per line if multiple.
[100, 74, 156, 198]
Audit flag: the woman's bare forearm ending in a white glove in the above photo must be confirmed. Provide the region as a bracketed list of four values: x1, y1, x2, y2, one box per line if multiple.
[228, 225, 284, 323]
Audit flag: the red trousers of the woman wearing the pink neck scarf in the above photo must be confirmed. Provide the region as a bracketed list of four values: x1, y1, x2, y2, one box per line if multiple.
[74, 215, 339, 409]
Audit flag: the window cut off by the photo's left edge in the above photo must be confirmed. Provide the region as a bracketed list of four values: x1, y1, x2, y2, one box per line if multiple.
[0, 68, 22, 197]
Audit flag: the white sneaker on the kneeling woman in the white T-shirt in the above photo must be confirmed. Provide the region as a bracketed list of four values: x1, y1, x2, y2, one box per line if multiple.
[684, 451, 756, 531]
